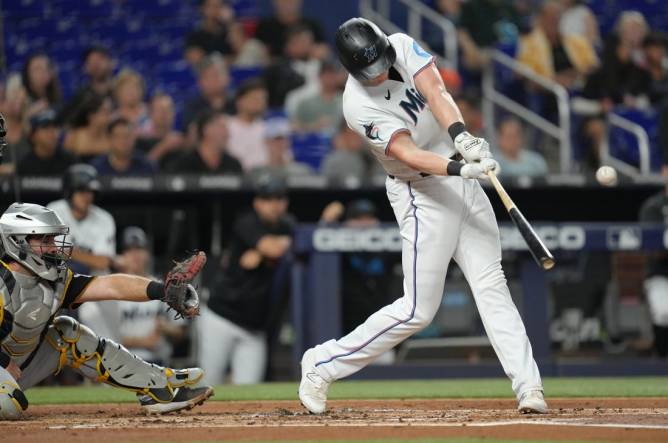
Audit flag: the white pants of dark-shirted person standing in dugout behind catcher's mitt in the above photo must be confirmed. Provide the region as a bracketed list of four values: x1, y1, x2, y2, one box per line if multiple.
[197, 306, 267, 385]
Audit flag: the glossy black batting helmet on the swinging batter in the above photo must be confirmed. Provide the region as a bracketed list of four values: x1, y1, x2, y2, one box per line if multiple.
[336, 17, 397, 81]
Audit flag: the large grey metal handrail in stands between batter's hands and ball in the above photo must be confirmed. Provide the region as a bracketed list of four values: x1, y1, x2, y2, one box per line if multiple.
[482, 50, 572, 174]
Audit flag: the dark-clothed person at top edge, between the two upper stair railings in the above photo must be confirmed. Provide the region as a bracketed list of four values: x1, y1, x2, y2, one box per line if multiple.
[458, 0, 524, 71]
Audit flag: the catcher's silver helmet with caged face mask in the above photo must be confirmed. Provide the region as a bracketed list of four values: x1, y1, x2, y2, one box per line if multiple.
[0, 203, 72, 281]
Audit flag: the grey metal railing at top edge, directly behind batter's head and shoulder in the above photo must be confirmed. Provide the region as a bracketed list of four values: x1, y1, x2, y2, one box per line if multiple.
[360, 0, 458, 69]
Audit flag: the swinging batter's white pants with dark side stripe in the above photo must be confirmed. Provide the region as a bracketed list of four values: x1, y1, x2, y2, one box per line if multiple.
[315, 176, 542, 398]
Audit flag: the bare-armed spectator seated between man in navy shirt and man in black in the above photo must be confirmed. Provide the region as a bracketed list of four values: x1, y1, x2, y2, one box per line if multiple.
[136, 92, 185, 166]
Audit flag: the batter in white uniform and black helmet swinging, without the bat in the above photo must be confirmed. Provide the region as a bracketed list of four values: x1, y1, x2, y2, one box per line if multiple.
[299, 18, 547, 413]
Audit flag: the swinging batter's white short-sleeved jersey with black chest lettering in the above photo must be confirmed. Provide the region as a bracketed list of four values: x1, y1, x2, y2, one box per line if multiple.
[343, 34, 456, 180]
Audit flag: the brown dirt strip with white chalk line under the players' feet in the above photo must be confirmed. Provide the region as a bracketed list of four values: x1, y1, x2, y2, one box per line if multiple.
[0, 398, 668, 443]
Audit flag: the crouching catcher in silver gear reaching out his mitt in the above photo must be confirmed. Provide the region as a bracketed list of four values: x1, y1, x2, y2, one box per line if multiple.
[0, 203, 213, 419]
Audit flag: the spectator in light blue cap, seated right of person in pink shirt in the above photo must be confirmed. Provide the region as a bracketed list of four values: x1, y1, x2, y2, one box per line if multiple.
[249, 117, 314, 181]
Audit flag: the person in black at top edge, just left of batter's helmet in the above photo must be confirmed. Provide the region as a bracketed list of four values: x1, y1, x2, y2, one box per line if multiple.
[255, 0, 328, 58]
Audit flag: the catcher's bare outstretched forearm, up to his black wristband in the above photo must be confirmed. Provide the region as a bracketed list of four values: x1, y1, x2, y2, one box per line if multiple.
[76, 274, 151, 303]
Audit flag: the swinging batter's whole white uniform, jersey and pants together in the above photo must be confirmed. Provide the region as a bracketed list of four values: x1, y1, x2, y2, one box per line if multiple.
[310, 30, 542, 398]
